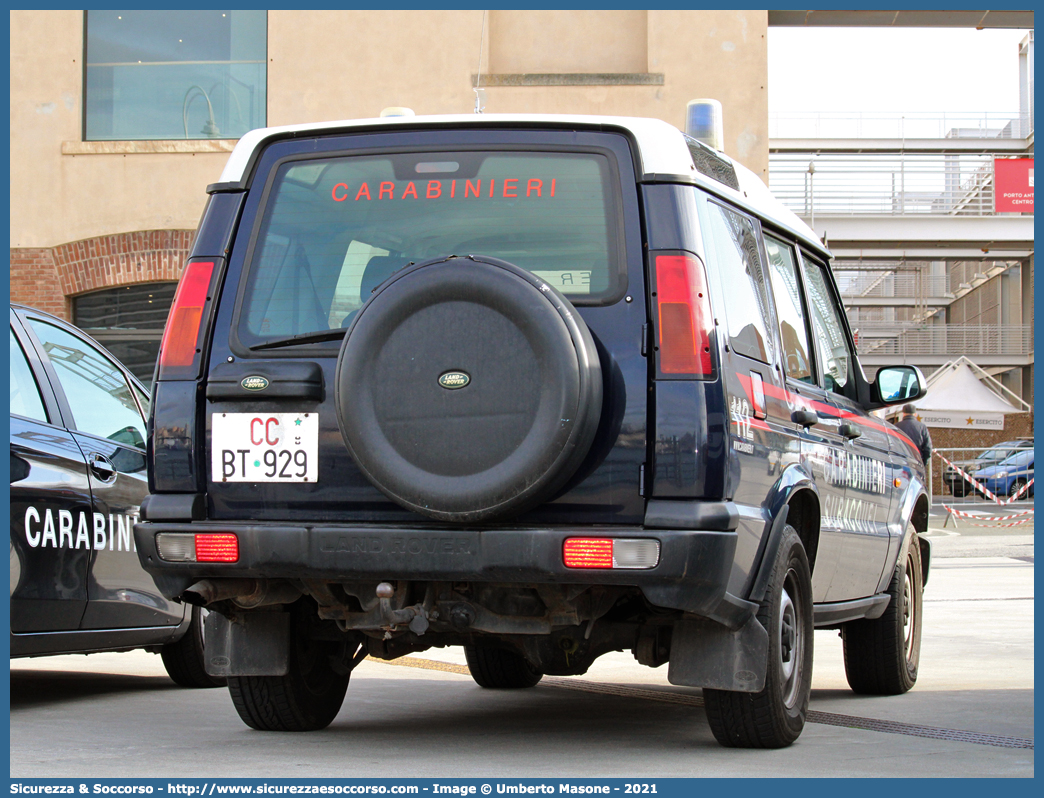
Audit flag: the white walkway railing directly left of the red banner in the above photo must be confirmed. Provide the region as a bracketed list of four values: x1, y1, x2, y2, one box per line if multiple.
[768, 152, 1027, 218]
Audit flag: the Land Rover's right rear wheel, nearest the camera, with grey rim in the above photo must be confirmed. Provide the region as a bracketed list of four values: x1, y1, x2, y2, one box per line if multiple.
[704, 526, 813, 748]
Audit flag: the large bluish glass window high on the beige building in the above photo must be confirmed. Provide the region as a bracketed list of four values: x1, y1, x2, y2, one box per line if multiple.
[84, 9, 268, 141]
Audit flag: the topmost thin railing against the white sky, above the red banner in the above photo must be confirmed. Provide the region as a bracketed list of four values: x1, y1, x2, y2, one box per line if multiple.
[768, 111, 1031, 139]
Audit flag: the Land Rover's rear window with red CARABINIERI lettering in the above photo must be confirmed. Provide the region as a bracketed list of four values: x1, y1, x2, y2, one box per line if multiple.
[240, 151, 624, 339]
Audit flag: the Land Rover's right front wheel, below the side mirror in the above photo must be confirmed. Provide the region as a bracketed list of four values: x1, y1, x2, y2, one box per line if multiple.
[841, 533, 923, 696]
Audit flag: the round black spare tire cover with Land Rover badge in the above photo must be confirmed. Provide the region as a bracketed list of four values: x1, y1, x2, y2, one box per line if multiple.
[334, 256, 602, 522]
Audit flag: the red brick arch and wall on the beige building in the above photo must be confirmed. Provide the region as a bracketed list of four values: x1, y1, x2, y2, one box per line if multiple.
[10, 230, 195, 319]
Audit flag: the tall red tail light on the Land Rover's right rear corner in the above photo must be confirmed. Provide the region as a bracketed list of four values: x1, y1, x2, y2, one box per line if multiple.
[655, 253, 714, 377]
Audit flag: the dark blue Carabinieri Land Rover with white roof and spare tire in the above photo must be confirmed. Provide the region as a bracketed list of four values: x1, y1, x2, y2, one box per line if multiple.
[135, 115, 929, 747]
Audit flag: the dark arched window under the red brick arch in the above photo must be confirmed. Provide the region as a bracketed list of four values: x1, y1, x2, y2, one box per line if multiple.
[72, 283, 177, 385]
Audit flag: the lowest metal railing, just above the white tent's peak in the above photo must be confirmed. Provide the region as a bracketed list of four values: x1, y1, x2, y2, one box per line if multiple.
[853, 322, 1033, 357]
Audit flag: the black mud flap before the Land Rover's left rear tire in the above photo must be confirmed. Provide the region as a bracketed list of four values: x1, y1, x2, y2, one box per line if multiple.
[204, 612, 290, 676]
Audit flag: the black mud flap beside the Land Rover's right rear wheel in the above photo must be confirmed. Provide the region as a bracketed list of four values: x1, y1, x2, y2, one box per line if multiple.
[667, 617, 768, 693]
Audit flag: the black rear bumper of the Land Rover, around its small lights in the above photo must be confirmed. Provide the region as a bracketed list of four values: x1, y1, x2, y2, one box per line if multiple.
[135, 521, 736, 615]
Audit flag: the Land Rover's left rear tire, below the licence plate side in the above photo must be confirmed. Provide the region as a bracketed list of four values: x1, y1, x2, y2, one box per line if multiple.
[229, 616, 351, 731]
